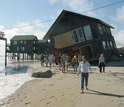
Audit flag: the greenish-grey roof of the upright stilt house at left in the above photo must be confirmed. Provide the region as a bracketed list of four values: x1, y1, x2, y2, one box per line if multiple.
[11, 35, 36, 40]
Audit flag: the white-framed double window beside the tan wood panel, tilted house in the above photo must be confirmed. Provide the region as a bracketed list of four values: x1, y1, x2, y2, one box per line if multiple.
[72, 28, 85, 43]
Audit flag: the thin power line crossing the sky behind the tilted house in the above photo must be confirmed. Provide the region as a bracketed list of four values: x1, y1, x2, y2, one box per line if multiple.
[1, 0, 124, 30]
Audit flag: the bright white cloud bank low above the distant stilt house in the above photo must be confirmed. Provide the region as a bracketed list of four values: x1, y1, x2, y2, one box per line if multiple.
[0, 20, 48, 55]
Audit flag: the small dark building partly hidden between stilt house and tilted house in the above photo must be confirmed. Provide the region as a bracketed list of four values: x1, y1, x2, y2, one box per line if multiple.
[38, 40, 49, 54]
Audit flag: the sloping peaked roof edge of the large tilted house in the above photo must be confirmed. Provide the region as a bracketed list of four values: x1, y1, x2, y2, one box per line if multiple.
[43, 10, 114, 39]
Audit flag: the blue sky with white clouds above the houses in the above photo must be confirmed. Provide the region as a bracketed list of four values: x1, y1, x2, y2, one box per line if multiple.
[0, 0, 124, 55]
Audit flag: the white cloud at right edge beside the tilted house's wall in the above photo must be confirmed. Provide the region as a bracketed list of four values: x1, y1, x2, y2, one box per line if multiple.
[114, 29, 124, 47]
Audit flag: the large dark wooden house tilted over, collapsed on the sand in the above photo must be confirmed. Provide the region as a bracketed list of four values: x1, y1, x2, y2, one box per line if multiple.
[44, 10, 116, 61]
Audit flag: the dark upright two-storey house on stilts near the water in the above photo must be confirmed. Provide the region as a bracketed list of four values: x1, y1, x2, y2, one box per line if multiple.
[10, 35, 38, 58]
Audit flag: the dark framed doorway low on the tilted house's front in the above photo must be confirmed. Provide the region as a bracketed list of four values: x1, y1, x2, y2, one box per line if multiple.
[80, 45, 93, 59]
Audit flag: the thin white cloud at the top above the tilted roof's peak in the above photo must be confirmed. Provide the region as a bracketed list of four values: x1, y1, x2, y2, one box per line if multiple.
[48, 0, 97, 17]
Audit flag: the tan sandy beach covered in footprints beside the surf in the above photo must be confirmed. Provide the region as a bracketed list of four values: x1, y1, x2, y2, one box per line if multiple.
[0, 63, 124, 107]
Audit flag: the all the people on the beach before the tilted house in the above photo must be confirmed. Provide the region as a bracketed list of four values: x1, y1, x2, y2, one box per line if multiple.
[40, 53, 106, 93]
